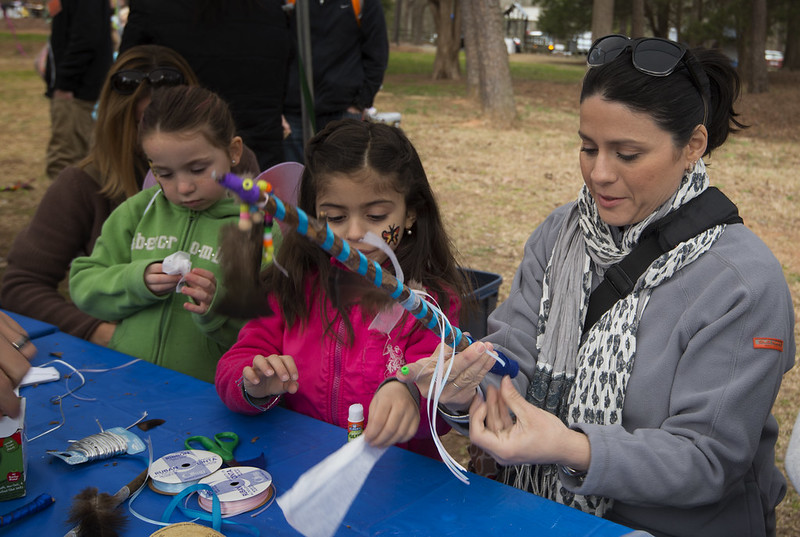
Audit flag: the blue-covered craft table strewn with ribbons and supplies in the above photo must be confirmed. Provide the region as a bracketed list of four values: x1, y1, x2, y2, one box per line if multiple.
[0, 332, 630, 537]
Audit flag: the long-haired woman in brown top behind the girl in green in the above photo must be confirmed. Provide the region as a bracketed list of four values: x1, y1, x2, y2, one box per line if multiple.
[0, 45, 258, 345]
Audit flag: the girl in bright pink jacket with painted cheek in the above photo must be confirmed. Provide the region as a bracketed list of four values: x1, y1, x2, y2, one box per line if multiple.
[215, 120, 468, 457]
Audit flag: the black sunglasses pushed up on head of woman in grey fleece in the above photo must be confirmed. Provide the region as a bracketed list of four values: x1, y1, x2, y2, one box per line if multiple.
[586, 34, 708, 125]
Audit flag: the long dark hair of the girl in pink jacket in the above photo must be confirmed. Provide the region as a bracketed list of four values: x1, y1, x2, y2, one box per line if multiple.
[263, 119, 469, 333]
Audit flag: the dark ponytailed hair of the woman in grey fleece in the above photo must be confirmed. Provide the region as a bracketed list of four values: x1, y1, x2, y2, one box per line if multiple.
[581, 44, 745, 156]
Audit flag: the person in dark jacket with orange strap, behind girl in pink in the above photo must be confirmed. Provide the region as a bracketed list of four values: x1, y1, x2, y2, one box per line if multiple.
[283, 0, 389, 162]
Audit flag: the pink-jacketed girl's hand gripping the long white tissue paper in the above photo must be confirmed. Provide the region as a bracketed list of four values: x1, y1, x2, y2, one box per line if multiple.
[364, 382, 419, 448]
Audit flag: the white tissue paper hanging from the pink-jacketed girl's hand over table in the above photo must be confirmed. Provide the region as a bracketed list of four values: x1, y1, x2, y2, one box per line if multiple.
[276, 436, 386, 537]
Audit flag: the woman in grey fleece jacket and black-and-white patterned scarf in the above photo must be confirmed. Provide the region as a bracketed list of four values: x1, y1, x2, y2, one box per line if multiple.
[404, 36, 795, 537]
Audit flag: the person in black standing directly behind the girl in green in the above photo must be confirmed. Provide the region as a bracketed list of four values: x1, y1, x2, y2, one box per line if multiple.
[120, 0, 290, 170]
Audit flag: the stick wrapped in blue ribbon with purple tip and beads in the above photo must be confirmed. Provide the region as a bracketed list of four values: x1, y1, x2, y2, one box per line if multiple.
[218, 173, 519, 378]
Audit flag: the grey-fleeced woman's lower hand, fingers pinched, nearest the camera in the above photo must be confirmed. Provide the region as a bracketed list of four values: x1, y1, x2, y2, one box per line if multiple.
[469, 377, 591, 470]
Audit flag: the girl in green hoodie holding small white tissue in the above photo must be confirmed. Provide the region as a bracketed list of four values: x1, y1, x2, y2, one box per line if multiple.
[70, 86, 253, 381]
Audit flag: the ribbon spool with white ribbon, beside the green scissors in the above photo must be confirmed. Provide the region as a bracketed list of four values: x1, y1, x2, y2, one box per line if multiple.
[147, 449, 222, 495]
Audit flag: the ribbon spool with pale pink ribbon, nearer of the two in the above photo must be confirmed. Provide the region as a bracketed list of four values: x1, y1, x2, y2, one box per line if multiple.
[197, 466, 275, 516]
